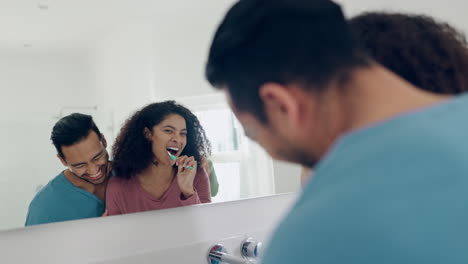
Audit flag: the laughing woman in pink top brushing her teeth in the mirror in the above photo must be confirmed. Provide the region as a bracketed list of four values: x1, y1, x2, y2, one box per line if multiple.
[106, 101, 211, 215]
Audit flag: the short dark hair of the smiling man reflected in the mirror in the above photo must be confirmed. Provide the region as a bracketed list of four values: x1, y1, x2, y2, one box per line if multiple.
[50, 113, 102, 160]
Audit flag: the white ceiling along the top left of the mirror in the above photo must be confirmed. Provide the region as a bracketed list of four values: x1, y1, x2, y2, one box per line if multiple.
[0, 0, 233, 52]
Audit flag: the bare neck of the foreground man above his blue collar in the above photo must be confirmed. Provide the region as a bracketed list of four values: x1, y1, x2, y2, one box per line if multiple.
[303, 64, 449, 161]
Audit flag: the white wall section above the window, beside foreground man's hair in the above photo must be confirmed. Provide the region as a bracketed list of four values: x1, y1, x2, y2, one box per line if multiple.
[154, 0, 235, 99]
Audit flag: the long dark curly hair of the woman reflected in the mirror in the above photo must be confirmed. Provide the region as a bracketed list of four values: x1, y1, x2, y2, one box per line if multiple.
[112, 101, 211, 179]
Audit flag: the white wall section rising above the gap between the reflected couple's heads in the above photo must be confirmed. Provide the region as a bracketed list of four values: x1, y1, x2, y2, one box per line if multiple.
[88, 21, 156, 144]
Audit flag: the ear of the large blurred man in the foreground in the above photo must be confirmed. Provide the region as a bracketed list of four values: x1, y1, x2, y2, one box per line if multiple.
[259, 83, 300, 127]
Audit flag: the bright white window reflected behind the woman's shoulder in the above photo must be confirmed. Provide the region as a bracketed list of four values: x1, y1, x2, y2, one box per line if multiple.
[176, 95, 275, 202]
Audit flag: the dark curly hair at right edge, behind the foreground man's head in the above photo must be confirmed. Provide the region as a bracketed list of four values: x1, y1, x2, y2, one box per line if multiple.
[349, 12, 468, 94]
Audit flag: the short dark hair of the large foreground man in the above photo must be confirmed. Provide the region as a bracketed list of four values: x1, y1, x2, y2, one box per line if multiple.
[205, 0, 369, 122]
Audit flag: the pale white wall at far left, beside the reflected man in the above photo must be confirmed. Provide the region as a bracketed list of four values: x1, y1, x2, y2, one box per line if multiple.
[0, 52, 96, 229]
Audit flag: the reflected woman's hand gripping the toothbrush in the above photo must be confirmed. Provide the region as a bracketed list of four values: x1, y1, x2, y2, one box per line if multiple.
[176, 156, 197, 198]
